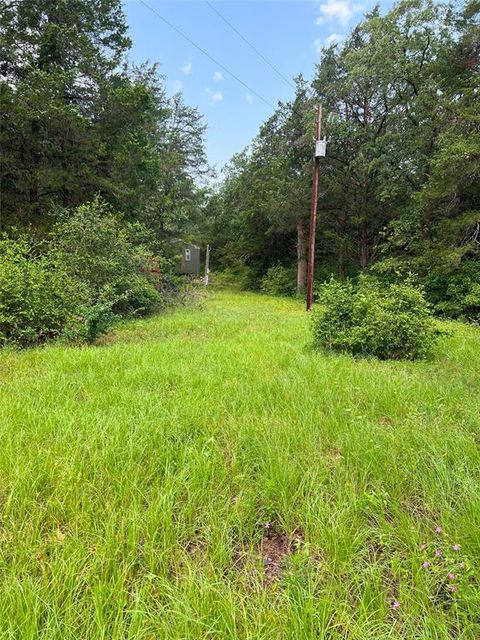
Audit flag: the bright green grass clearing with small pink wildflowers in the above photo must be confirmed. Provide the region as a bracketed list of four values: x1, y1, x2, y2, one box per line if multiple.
[0, 292, 480, 640]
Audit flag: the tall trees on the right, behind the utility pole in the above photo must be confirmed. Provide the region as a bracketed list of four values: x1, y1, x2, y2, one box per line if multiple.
[209, 0, 480, 319]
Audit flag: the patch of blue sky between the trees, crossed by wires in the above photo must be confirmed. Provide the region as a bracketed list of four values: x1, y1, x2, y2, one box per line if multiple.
[124, 0, 392, 169]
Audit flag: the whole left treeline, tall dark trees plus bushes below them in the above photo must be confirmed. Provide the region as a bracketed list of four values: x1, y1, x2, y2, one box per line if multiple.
[0, 0, 208, 344]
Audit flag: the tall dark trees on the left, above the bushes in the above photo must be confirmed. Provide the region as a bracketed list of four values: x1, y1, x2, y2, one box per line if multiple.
[0, 0, 207, 240]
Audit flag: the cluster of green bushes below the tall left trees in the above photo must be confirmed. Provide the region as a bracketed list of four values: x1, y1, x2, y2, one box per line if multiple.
[0, 198, 182, 345]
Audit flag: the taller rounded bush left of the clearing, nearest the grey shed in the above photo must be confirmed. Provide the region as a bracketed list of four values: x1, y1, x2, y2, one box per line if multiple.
[54, 198, 162, 315]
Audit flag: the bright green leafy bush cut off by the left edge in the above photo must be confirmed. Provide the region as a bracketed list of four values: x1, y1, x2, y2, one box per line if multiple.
[0, 239, 88, 346]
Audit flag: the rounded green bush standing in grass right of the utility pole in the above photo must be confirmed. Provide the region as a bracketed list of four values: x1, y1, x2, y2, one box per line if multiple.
[313, 277, 441, 360]
